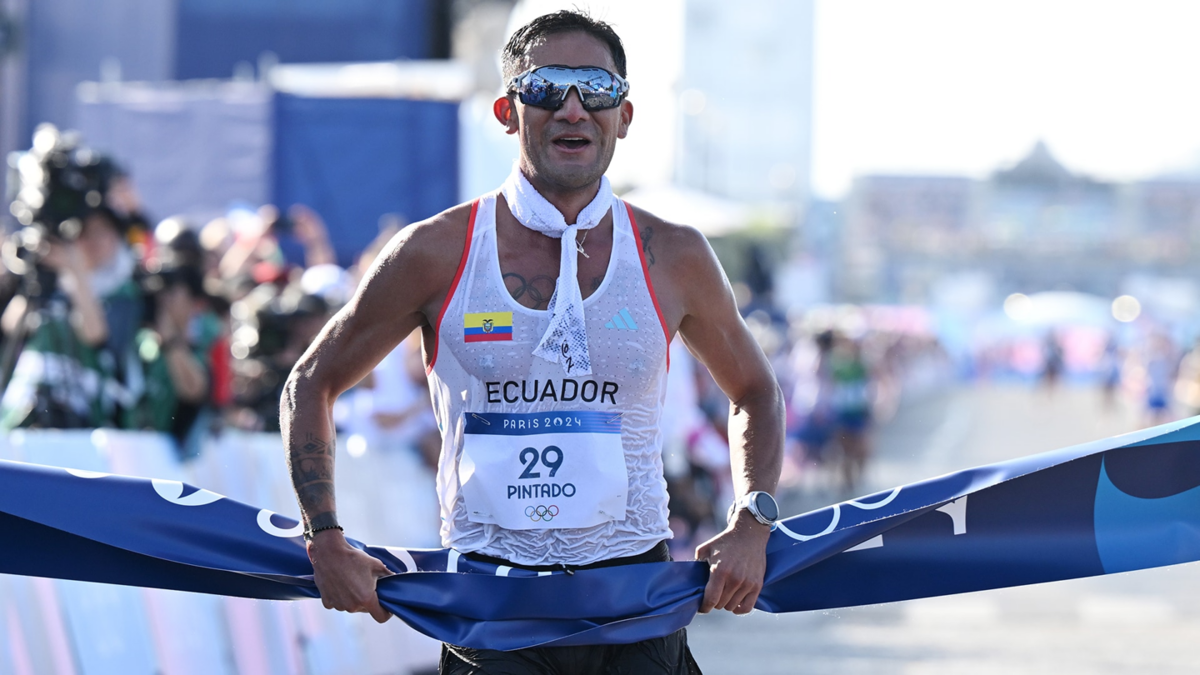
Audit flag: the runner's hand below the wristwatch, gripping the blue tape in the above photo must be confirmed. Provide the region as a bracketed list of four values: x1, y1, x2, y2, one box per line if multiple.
[696, 509, 770, 614]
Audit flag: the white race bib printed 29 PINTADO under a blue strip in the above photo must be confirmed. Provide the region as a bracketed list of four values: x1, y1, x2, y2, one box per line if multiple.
[458, 411, 629, 530]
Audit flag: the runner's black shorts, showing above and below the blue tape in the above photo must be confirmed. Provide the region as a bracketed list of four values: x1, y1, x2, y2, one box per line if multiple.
[438, 542, 701, 675]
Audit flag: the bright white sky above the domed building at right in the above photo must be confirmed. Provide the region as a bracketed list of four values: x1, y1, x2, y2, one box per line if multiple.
[812, 0, 1200, 198]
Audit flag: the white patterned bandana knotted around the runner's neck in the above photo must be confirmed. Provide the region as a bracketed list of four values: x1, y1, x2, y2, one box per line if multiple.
[500, 163, 612, 375]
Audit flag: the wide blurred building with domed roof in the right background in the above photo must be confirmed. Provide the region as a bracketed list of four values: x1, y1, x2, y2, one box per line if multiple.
[838, 143, 1200, 303]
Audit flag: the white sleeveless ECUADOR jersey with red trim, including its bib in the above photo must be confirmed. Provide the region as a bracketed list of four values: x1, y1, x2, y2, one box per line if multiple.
[428, 193, 671, 565]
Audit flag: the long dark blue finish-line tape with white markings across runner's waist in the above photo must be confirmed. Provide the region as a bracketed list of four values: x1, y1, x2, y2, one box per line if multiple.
[7, 417, 1200, 650]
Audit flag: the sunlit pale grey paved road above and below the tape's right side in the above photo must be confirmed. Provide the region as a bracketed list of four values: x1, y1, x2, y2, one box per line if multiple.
[689, 387, 1200, 675]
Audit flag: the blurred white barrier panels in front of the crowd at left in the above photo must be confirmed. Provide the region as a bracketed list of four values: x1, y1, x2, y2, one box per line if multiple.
[0, 429, 439, 675]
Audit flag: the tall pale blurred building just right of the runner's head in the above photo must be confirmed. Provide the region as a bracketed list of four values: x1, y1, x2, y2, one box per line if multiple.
[677, 0, 814, 215]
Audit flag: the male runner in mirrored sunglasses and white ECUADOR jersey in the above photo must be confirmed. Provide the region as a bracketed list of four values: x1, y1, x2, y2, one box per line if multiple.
[281, 12, 784, 674]
